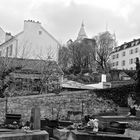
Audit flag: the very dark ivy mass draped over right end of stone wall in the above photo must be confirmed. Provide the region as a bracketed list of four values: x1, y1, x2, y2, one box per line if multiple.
[91, 84, 135, 107]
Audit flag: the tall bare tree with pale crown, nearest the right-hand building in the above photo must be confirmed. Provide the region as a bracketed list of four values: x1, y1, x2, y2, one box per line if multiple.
[93, 31, 116, 73]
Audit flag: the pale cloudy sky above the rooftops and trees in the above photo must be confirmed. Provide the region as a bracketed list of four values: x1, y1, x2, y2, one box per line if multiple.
[0, 0, 140, 44]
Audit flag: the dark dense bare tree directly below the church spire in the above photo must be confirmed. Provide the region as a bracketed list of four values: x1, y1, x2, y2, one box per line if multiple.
[69, 39, 96, 73]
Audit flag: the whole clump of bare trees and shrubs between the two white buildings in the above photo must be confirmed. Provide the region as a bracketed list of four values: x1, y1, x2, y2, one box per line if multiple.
[59, 32, 116, 83]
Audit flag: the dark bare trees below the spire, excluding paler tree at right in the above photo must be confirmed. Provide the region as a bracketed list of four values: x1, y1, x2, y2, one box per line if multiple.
[59, 39, 96, 74]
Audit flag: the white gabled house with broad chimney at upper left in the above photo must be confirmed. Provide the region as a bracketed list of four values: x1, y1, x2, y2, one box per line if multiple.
[0, 20, 60, 61]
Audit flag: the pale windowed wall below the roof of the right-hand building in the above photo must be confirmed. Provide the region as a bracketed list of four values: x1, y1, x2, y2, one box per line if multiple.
[111, 44, 140, 70]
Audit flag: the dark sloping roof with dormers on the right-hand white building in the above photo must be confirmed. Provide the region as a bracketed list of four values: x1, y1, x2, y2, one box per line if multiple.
[112, 38, 140, 53]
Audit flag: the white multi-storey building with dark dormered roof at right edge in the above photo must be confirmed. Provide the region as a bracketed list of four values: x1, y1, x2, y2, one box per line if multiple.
[111, 39, 140, 70]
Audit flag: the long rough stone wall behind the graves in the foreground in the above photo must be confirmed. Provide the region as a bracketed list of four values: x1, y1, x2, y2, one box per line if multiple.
[0, 91, 114, 121]
